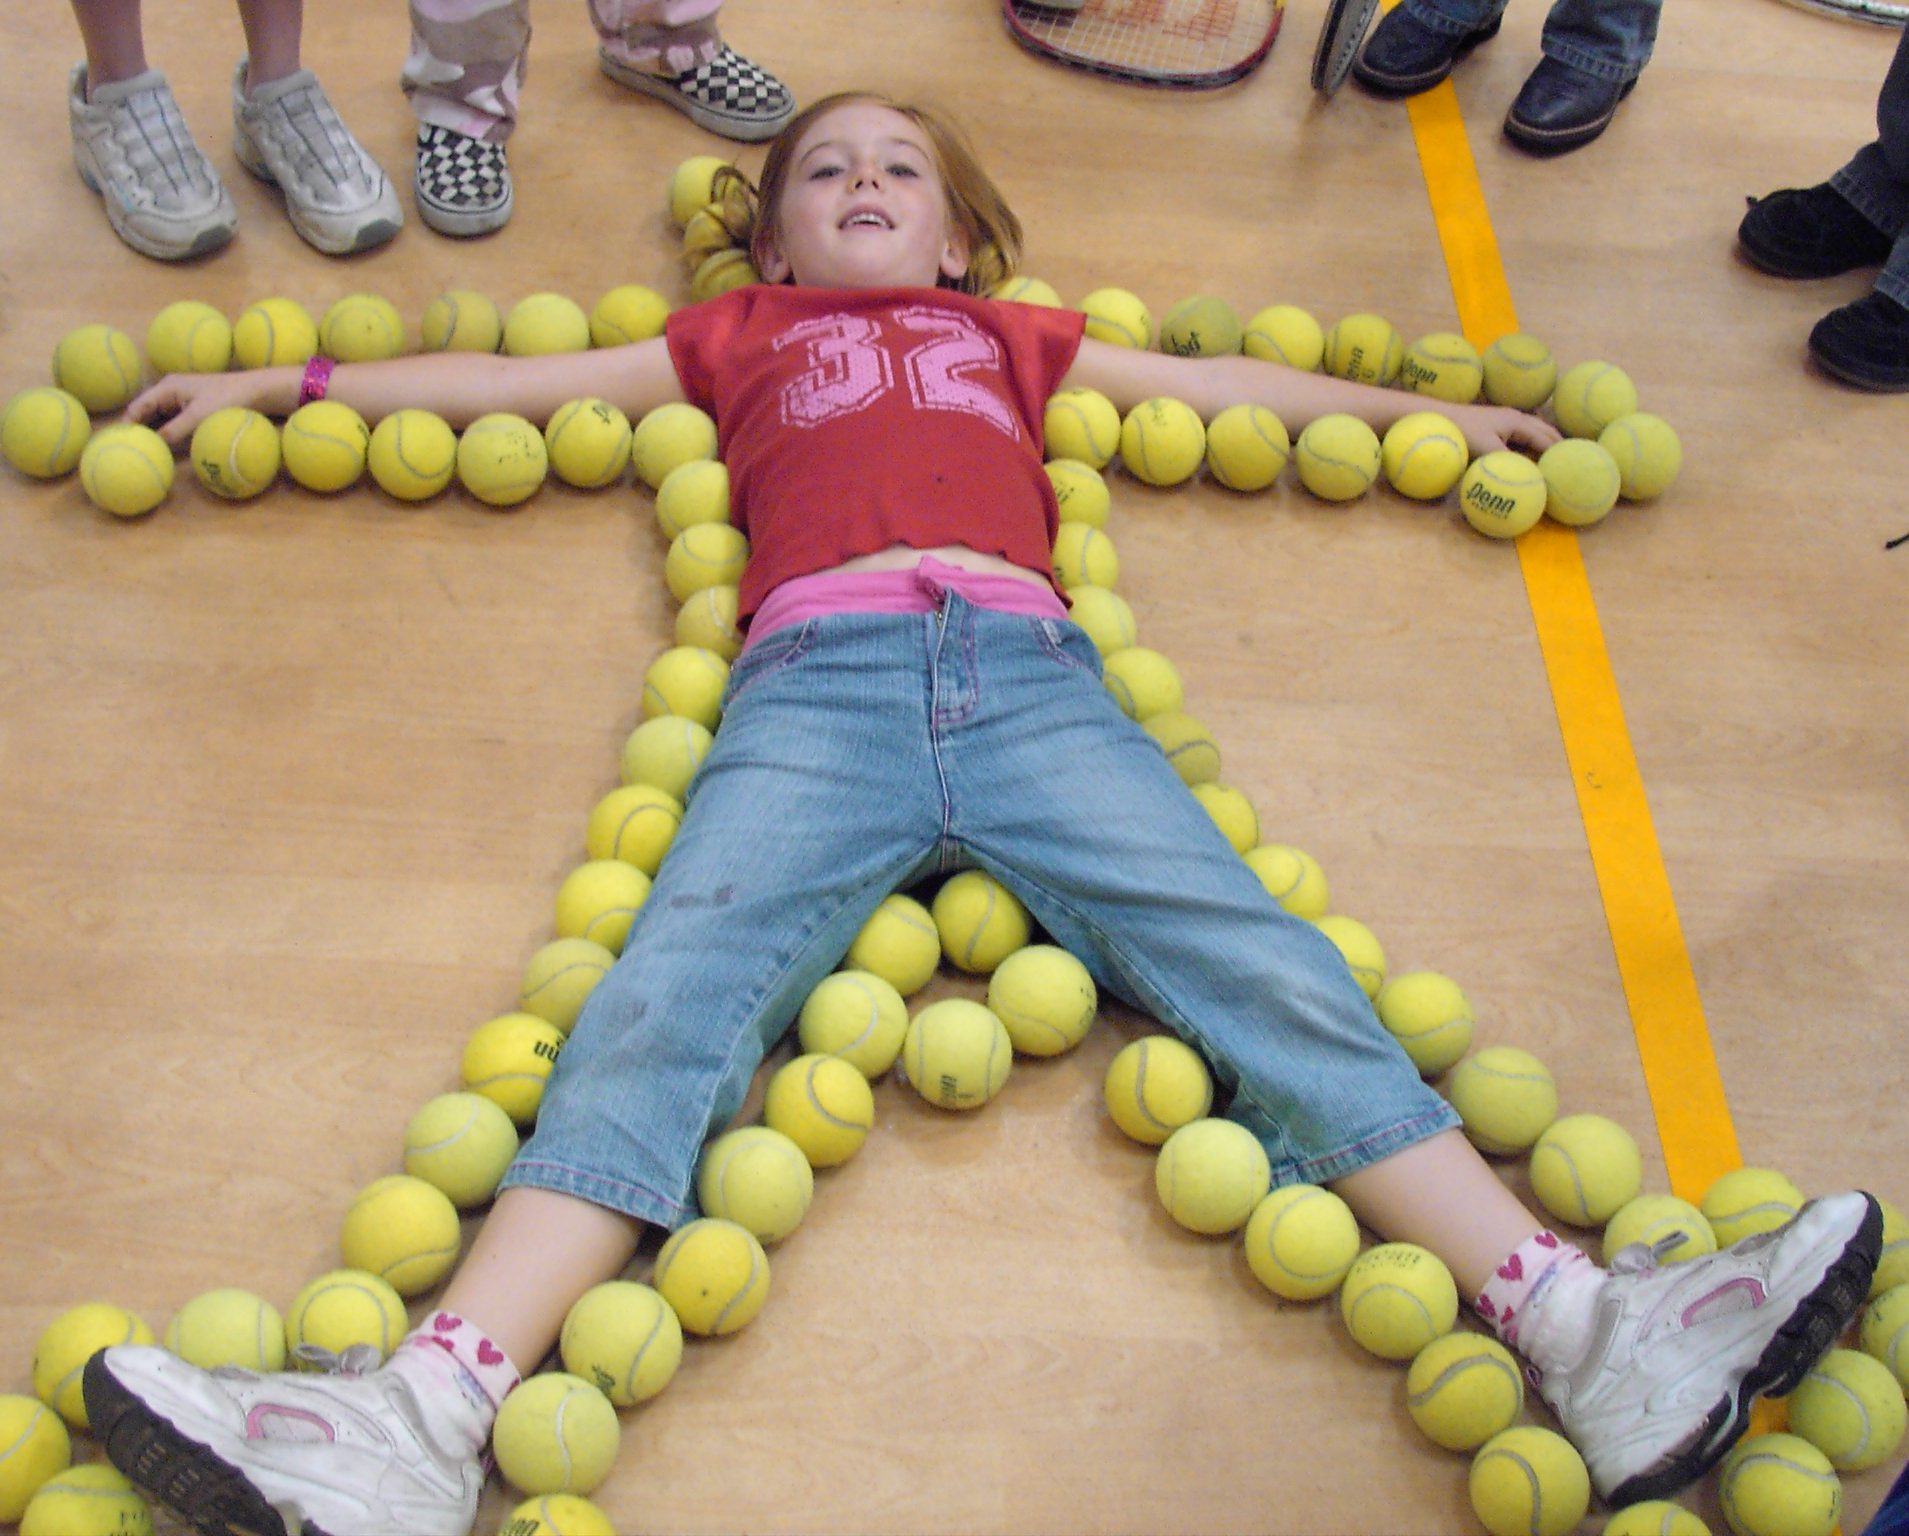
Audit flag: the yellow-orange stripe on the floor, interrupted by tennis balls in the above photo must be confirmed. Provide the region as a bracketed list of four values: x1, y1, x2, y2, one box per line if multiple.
[1407, 82, 1741, 1200]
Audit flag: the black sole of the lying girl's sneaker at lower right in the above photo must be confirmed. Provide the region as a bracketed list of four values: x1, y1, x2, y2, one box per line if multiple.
[1603, 1196, 1882, 1509]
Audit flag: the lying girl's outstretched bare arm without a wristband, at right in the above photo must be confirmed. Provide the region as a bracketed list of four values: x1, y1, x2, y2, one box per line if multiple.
[1061, 338, 1560, 454]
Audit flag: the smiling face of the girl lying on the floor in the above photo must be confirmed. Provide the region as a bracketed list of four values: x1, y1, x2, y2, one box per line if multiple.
[762, 101, 968, 288]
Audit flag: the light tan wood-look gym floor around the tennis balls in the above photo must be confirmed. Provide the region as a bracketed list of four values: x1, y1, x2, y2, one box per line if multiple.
[0, 0, 1909, 1532]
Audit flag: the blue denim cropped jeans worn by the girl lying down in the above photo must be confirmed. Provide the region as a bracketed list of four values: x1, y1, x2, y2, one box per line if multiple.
[504, 593, 1457, 1227]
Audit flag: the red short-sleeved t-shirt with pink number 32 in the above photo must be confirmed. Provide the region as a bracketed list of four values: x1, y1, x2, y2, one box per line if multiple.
[664, 284, 1086, 616]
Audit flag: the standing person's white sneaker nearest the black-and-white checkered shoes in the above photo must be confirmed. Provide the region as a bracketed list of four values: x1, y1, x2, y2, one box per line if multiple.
[233, 59, 405, 256]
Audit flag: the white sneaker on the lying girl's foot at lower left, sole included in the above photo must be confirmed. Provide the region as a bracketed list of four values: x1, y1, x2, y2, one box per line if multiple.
[82, 1345, 483, 1536]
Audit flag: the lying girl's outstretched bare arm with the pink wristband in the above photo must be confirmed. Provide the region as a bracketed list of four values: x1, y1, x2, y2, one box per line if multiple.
[126, 336, 683, 448]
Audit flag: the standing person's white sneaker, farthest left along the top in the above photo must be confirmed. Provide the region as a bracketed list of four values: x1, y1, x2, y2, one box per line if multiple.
[67, 65, 239, 261]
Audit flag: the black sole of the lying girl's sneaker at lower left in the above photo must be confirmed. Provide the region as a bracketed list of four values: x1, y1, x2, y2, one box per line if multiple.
[80, 1351, 339, 1536]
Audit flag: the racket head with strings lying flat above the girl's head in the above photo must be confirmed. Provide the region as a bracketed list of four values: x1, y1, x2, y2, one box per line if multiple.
[1000, 0, 1285, 90]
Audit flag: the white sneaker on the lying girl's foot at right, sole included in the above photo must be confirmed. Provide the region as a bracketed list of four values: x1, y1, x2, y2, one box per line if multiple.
[1539, 1193, 1882, 1509]
